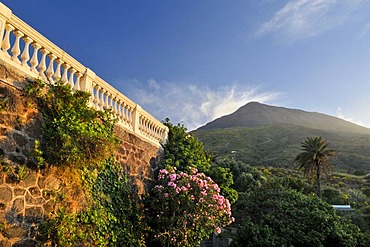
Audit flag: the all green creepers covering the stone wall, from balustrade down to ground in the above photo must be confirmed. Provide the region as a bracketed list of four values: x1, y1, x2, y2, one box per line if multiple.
[24, 80, 143, 246]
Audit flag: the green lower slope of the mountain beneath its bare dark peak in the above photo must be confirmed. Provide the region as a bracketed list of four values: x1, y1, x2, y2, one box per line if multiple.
[193, 124, 370, 173]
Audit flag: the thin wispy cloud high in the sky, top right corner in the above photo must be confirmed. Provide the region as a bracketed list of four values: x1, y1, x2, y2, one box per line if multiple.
[255, 0, 369, 42]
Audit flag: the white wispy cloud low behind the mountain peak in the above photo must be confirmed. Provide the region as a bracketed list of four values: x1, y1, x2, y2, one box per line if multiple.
[125, 80, 280, 130]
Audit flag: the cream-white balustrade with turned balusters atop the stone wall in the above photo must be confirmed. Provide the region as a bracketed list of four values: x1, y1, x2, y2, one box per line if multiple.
[0, 3, 168, 146]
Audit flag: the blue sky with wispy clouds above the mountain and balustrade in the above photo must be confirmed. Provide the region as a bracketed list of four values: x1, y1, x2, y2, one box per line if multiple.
[2, 0, 370, 129]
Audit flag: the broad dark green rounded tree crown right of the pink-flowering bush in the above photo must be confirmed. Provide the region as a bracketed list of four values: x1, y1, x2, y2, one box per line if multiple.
[232, 182, 365, 247]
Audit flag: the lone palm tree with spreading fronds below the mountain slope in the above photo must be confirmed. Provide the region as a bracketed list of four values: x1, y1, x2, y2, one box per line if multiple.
[294, 136, 336, 197]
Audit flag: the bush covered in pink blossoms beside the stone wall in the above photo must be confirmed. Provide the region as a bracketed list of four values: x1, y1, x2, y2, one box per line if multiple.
[147, 168, 234, 246]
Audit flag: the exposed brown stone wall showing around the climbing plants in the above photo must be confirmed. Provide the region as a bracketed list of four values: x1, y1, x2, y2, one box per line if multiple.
[0, 60, 159, 246]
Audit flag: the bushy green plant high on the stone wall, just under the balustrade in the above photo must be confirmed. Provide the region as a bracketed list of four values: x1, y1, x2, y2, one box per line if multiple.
[25, 80, 117, 167]
